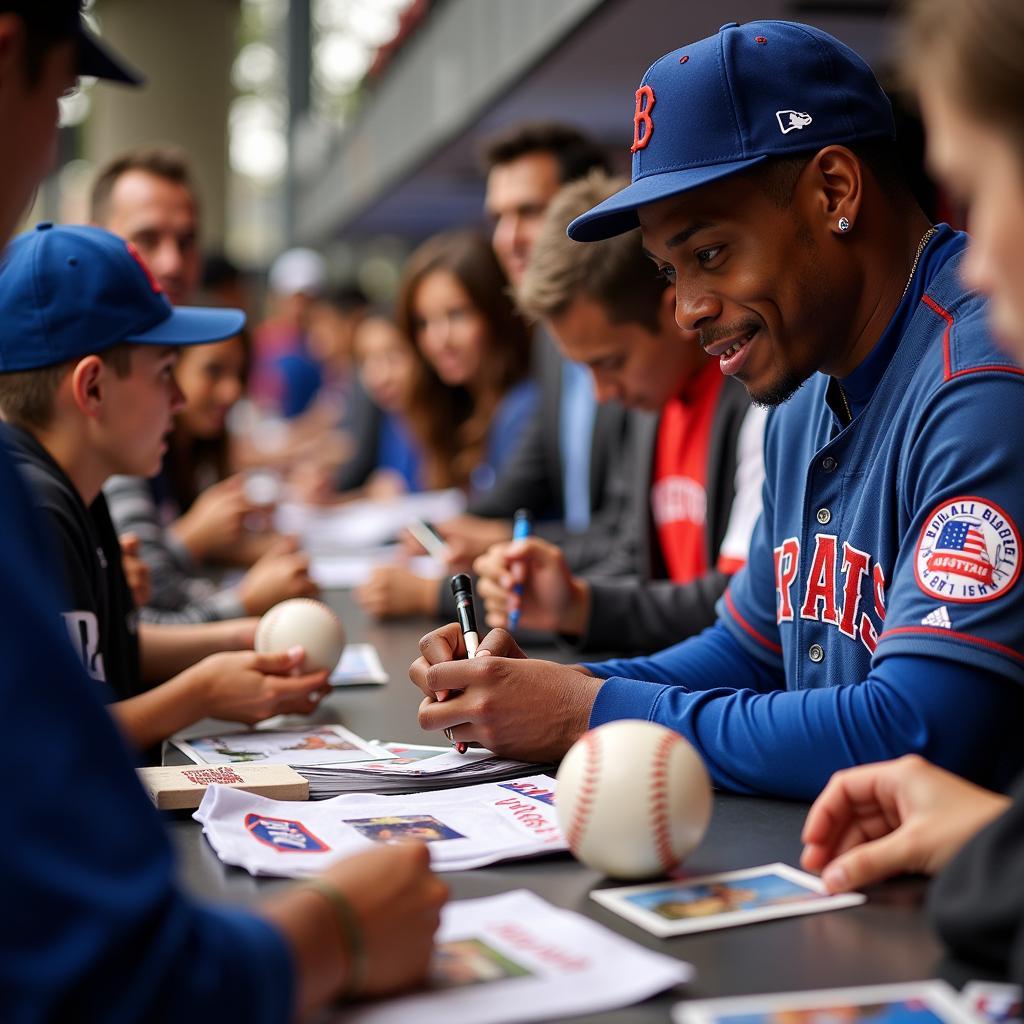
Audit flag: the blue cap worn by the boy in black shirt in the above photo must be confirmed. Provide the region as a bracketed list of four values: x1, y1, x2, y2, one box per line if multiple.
[0, 223, 246, 373]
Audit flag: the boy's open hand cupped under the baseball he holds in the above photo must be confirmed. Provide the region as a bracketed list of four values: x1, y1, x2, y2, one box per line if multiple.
[179, 647, 331, 725]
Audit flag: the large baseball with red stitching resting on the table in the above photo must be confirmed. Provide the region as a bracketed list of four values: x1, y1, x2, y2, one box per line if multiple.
[555, 721, 711, 879]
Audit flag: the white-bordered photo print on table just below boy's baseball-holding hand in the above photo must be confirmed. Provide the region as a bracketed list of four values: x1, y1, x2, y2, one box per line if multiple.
[171, 725, 394, 768]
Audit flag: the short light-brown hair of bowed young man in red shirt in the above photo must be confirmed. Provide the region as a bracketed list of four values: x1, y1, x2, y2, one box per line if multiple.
[516, 171, 668, 333]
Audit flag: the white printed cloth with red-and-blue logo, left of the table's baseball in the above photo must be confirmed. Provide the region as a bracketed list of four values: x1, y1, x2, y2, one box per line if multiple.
[194, 775, 568, 878]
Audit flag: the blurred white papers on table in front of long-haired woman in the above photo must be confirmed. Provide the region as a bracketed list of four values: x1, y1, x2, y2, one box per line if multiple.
[275, 488, 466, 552]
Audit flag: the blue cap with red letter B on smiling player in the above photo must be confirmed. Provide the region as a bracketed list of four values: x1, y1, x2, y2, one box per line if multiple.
[568, 22, 896, 242]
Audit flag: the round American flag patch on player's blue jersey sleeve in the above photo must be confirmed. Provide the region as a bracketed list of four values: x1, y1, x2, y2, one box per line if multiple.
[914, 496, 1020, 603]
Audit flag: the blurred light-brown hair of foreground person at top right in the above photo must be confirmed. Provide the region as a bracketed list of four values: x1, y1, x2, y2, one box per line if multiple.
[903, 0, 1024, 155]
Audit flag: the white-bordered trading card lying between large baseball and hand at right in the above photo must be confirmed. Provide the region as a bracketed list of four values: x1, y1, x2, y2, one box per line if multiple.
[590, 864, 865, 936]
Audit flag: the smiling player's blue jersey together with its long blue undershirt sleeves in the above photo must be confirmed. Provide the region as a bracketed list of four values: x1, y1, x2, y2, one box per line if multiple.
[589, 227, 1024, 798]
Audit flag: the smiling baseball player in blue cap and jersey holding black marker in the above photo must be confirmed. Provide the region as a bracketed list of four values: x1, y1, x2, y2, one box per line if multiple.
[412, 22, 1024, 798]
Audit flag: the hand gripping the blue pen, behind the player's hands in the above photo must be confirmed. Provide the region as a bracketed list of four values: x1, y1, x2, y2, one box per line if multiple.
[473, 537, 590, 636]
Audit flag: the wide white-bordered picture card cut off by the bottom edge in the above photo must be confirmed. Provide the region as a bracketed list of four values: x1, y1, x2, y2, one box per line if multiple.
[672, 981, 978, 1024]
